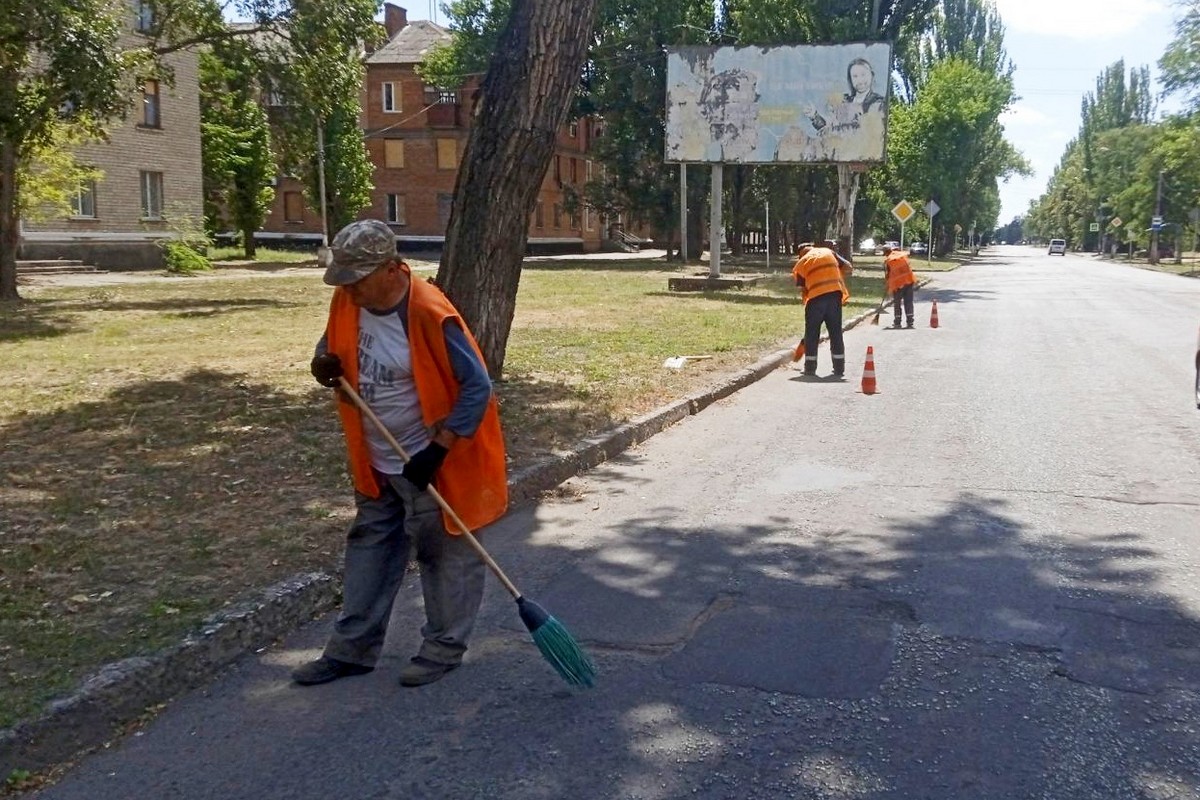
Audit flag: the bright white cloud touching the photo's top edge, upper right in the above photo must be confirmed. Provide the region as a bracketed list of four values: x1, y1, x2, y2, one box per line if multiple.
[996, 0, 1166, 42]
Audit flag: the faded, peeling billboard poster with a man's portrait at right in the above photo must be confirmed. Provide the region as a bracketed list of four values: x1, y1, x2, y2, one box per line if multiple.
[666, 42, 892, 164]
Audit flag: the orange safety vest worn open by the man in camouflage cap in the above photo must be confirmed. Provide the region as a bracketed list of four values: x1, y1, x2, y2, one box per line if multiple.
[325, 273, 509, 535]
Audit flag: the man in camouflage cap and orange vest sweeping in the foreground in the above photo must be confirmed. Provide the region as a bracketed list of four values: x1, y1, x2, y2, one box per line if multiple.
[300, 219, 508, 686]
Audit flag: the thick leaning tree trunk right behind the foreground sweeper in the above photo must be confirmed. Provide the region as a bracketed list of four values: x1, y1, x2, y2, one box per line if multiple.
[437, 0, 598, 378]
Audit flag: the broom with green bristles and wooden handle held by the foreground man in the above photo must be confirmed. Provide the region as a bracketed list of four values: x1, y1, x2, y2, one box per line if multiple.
[337, 378, 596, 686]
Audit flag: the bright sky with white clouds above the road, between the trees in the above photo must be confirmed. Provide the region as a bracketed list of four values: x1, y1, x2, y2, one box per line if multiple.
[392, 0, 1180, 224]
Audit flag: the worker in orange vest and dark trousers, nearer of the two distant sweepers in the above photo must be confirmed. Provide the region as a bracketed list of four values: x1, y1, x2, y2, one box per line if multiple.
[792, 242, 853, 378]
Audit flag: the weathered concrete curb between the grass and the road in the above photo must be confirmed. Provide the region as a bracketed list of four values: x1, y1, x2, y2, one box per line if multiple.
[0, 291, 902, 777]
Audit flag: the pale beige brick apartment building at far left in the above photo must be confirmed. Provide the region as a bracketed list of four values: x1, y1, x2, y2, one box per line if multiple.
[18, 0, 204, 269]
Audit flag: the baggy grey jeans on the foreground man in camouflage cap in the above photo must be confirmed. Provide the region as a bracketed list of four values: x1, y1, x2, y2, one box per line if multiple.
[325, 474, 486, 666]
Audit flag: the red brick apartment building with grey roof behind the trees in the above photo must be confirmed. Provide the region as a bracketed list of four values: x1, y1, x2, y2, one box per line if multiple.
[259, 2, 619, 252]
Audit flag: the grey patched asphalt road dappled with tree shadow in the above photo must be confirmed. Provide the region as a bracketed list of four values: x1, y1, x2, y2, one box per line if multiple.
[28, 247, 1200, 800]
